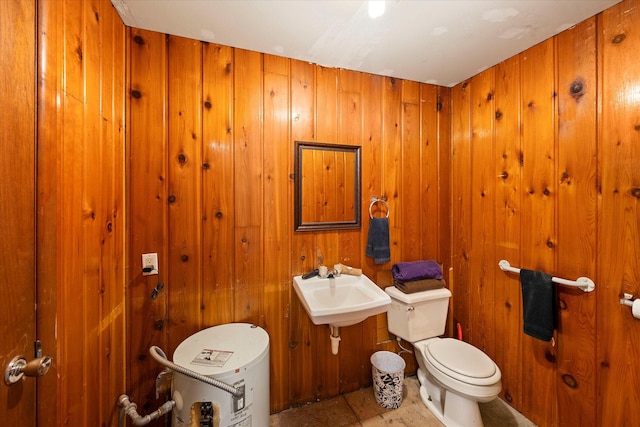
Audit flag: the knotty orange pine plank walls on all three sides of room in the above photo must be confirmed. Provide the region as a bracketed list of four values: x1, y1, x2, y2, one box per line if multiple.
[10, 0, 640, 426]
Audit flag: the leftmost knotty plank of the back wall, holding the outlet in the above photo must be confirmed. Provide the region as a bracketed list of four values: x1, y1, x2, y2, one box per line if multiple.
[126, 29, 169, 414]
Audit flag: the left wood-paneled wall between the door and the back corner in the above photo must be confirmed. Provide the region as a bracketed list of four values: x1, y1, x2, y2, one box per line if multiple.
[34, 0, 126, 426]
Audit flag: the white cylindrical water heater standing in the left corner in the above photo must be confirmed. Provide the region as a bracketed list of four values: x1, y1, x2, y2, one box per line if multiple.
[172, 323, 269, 427]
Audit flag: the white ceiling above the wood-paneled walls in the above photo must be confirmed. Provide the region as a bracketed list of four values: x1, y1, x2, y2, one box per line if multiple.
[111, 0, 620, 86]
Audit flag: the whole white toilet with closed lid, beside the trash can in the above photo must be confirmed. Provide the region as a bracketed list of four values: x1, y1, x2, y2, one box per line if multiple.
[385, 286, 502, 427]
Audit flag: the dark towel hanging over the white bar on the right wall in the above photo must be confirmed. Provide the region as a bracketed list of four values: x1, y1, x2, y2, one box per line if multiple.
[520, 269, 556, 341]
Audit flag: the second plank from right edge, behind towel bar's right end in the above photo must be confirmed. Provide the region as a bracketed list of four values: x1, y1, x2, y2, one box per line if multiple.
[555, 18, 598, 427]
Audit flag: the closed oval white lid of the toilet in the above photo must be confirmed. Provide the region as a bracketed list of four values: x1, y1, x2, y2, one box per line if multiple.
[426, 338, 497, 382]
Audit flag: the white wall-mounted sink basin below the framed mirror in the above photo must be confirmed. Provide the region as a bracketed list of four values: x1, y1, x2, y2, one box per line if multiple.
[293, 274, 391, 327]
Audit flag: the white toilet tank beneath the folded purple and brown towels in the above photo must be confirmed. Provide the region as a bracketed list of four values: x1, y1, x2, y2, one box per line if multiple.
[385, 286, 451, 342]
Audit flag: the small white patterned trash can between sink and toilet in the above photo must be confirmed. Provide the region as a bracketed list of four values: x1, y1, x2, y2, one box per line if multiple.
[371, 351, 406, 409]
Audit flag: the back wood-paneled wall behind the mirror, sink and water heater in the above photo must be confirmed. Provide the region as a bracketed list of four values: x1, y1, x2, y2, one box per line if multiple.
[127, 29, 450, 412]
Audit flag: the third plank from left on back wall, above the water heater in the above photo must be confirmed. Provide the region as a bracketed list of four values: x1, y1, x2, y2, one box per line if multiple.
[202, 44, 235, 325]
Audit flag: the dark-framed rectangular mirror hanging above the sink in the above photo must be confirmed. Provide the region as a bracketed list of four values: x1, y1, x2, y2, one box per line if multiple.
[294, 141, 361, 231]
